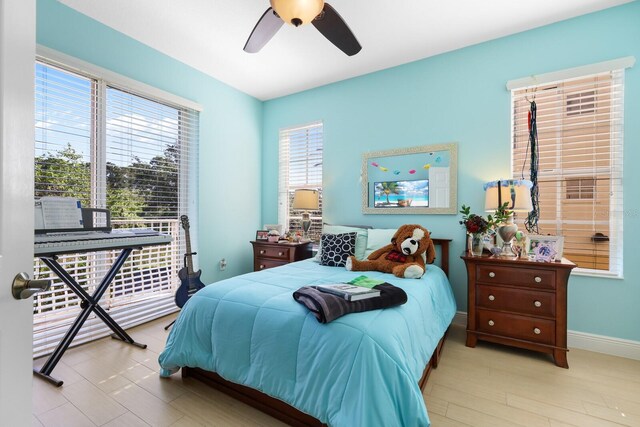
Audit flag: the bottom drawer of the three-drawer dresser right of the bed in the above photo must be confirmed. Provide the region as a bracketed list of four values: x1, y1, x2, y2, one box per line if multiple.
[477, 309, 556, 345]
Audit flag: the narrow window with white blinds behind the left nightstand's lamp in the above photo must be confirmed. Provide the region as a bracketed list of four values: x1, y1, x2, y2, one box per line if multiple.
[278, 122, 323, 242]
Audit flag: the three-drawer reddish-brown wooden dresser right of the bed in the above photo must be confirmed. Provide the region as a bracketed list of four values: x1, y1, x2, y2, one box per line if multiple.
[461, 253, 576, 368]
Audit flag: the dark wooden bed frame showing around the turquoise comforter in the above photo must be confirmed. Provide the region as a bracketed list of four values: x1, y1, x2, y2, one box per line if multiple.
[182, 239, 451, 427]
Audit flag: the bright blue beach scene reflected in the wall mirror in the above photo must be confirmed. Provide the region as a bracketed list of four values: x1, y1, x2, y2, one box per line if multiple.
[373, 179, 429, 208]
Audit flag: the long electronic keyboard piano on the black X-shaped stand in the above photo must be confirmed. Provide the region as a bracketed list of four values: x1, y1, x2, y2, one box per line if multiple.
[34, 229, 172, 257]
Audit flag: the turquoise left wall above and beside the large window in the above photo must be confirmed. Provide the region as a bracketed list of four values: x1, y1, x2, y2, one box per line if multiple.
[37, 0, 262, 283]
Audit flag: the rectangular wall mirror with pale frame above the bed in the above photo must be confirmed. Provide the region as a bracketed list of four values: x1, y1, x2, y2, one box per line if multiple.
[362, 142, 458, 215]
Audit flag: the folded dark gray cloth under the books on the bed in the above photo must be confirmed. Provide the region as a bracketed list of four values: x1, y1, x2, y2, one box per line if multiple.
[293, 283, 407, 323]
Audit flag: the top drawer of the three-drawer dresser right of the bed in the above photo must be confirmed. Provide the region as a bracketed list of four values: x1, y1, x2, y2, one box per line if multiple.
[476, 264, 556, 289]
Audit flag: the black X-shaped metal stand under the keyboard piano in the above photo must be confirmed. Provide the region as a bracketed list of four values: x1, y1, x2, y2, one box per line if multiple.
[33, 248, 147, 387]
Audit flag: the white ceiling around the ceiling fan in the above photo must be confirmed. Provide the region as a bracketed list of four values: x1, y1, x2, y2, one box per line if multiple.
[60, 0, 631, 100]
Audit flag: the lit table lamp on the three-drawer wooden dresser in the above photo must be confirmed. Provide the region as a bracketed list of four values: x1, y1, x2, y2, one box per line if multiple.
[484, 179, 533, 257]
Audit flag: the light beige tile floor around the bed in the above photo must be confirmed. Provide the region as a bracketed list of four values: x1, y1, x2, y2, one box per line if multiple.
[33, 315, 640, 427]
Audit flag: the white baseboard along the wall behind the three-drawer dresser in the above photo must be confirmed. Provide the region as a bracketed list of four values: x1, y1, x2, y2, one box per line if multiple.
[452, 311, 640, 360]
